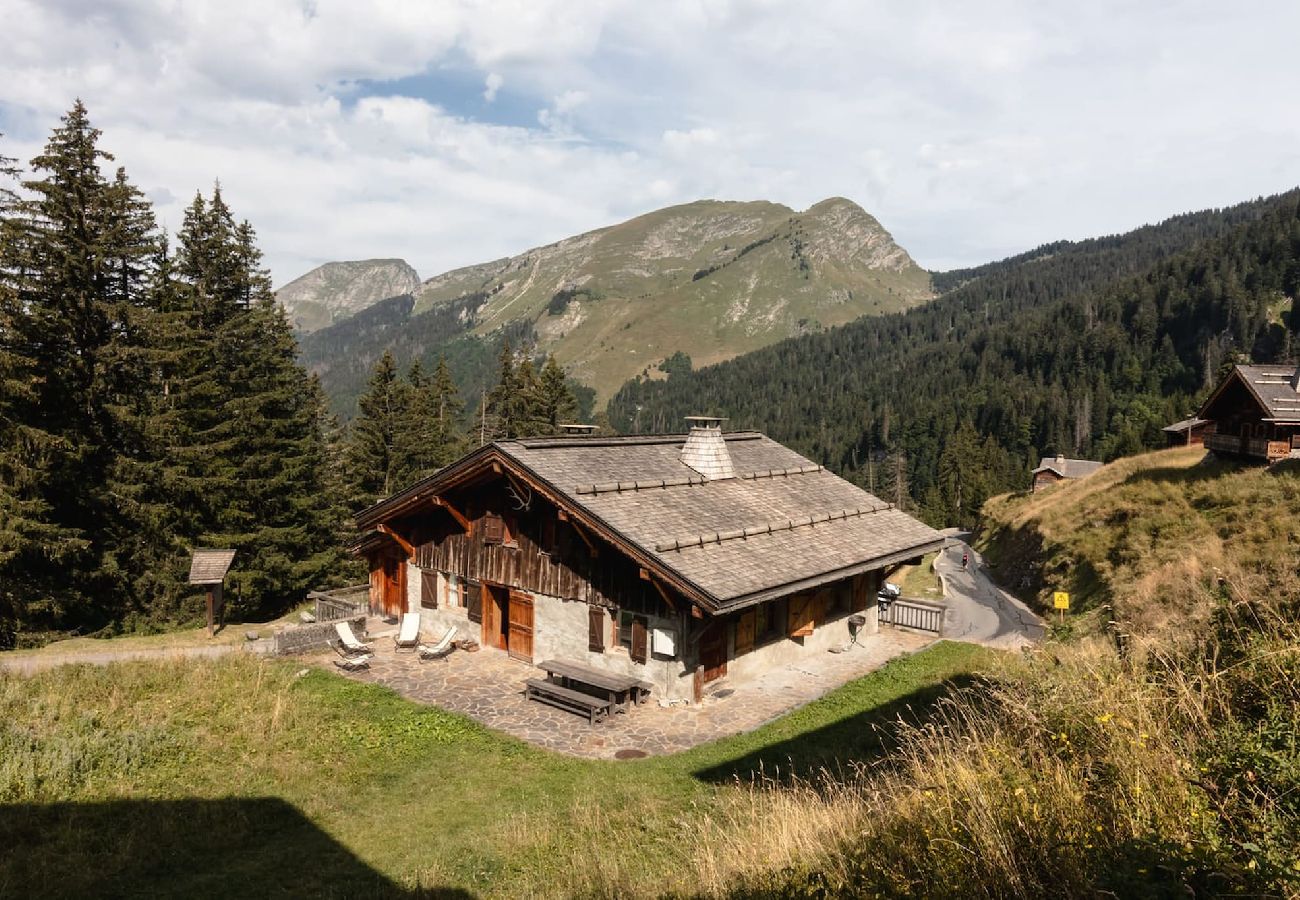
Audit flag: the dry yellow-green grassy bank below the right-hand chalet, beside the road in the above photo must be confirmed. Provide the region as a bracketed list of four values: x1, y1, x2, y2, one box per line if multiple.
[982, 447, 1300, 633]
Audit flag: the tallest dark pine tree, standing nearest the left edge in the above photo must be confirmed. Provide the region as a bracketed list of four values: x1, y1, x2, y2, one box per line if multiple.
[4, 101, 157, 628]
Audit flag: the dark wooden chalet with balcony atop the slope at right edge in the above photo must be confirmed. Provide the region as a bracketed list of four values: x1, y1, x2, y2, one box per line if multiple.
[1196, 365, 1300, 463]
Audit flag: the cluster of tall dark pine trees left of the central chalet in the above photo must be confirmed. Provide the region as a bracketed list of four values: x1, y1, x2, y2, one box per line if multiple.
[0, 103, 345, 648]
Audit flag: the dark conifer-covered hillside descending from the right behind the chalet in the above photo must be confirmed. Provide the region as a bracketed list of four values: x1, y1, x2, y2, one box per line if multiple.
[610, 191, 1300, 524]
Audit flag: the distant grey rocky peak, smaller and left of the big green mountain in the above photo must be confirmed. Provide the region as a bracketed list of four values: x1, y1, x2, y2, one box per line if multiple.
[276, 259, 420, 334]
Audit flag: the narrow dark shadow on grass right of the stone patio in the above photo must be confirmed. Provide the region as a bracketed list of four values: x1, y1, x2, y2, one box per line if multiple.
[692, 672, 980, 783]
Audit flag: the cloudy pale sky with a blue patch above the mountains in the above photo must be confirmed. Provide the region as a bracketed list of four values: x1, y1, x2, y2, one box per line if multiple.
[0, 0, 1300, 284]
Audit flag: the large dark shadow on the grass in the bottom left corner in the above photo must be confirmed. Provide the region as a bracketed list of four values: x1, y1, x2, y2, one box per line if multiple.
[0, 797, 472, 899]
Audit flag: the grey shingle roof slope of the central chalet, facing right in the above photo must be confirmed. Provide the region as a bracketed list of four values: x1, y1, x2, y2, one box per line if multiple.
[498, 432, 944, 606]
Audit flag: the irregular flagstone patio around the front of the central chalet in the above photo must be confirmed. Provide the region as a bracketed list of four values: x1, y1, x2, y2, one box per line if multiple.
[320, 628, 933, 758]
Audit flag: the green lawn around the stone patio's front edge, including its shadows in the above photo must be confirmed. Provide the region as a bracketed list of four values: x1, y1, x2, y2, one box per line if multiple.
[0, 642, 988, 896]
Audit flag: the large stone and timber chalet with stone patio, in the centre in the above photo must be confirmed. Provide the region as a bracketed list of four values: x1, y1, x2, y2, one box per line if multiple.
[354, 417, 944, 701]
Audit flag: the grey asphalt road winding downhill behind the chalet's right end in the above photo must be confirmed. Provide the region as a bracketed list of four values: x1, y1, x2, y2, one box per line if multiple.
[935, 529, 1047, 649]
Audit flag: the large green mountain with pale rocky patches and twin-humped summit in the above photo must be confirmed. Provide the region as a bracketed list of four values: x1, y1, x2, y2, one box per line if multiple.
[303, 198, 932, 406]
